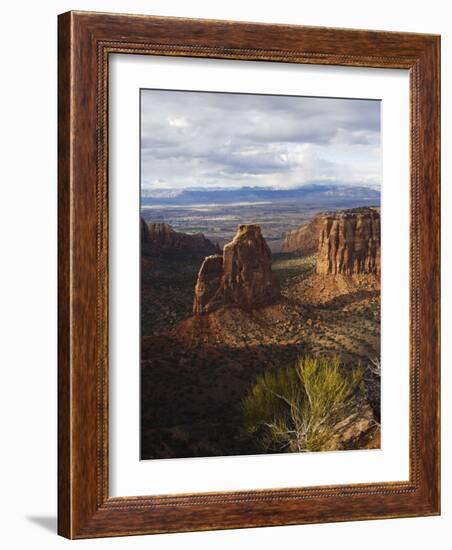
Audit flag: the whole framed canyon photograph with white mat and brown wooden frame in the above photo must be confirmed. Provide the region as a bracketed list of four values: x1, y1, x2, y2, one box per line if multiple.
[58, 12, 440, 538]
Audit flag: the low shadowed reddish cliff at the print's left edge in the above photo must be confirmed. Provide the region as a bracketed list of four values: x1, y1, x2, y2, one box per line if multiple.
[141, 219, 217, 254]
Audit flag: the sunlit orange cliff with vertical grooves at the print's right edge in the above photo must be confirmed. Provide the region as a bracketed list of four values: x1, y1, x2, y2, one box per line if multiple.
[316, 208, 380, 275]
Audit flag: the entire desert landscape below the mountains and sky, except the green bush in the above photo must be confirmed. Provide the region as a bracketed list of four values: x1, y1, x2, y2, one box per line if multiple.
[141, 195, 380, 459]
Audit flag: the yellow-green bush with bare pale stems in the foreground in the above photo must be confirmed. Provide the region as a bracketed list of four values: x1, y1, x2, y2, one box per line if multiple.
[242, 357, 363, 452]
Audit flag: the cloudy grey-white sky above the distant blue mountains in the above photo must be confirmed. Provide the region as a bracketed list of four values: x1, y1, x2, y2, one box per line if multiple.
[141, 90, 381, 194]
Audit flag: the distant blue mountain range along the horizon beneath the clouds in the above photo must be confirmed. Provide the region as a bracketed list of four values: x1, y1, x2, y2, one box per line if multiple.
[141, 184, 380, 206]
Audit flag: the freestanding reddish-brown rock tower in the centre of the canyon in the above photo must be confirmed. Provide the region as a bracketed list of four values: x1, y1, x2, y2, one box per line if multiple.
[193, 225, 280, 314]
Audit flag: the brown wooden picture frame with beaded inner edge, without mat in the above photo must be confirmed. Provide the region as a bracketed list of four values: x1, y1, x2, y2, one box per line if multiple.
[58, 12, 440, 538]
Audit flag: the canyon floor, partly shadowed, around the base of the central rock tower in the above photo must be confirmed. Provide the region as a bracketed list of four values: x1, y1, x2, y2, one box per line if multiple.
[141, 246, 380, 459]
